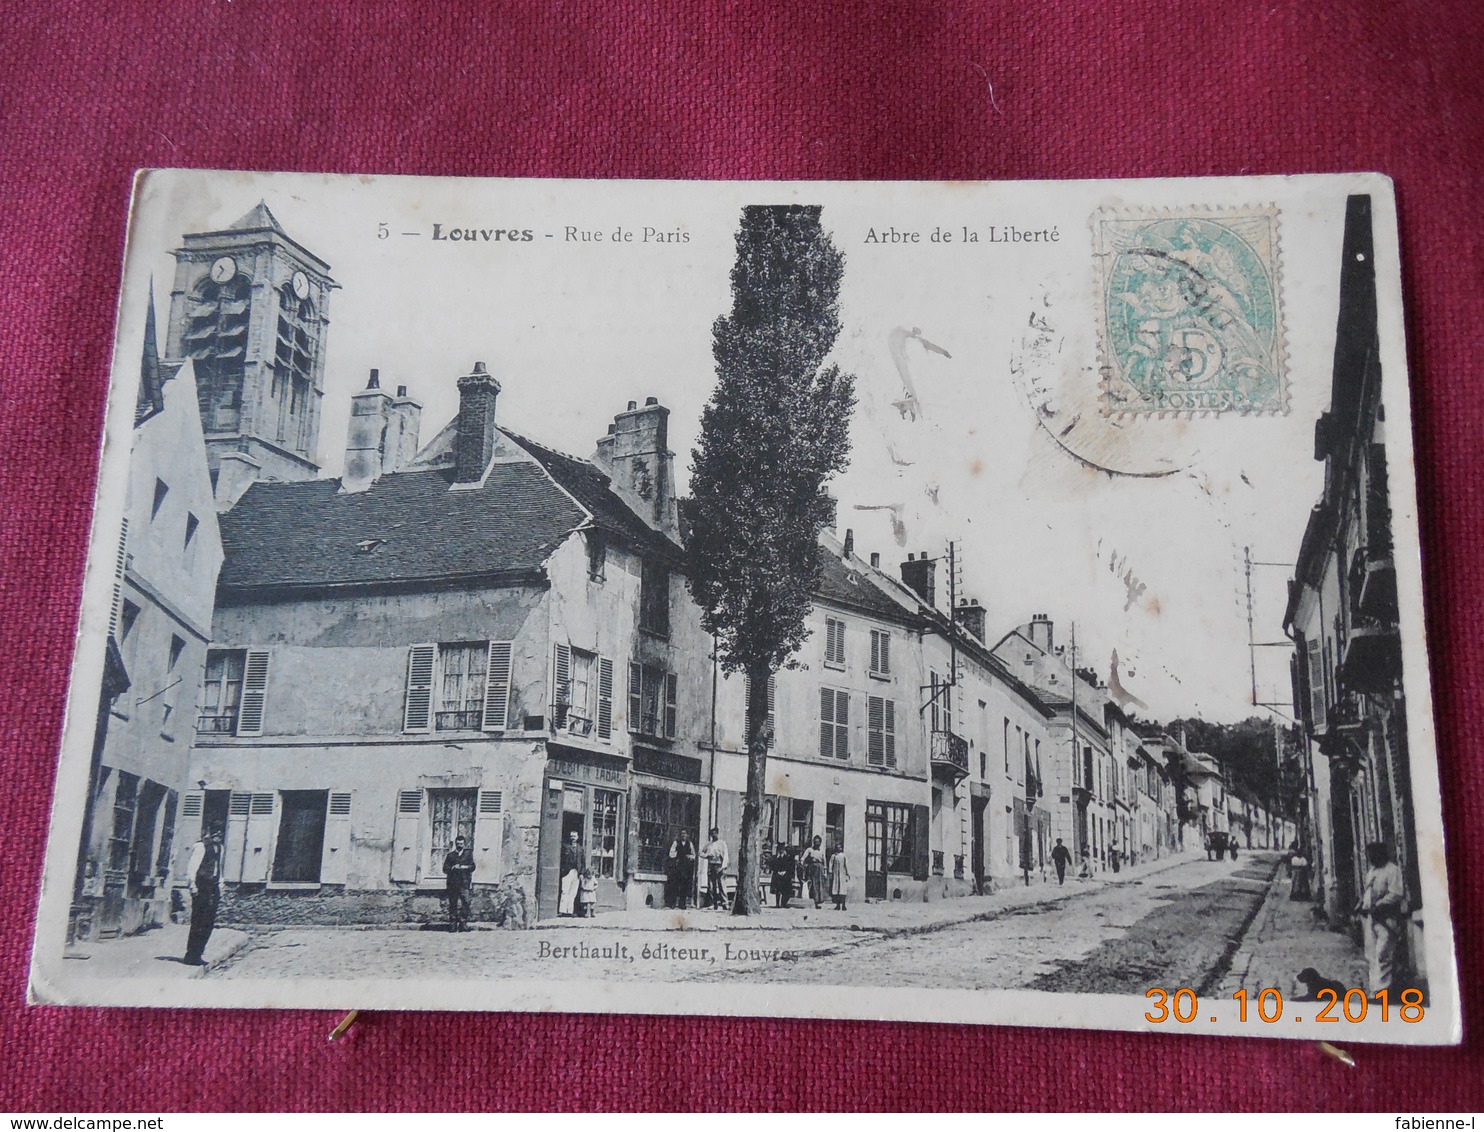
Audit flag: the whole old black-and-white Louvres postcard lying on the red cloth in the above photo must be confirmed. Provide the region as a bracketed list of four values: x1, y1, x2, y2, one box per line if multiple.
[31, 171, 1460, 1044]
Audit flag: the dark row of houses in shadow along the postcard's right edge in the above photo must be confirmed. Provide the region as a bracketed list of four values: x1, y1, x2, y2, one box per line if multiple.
[1284, 196, 1426, 978]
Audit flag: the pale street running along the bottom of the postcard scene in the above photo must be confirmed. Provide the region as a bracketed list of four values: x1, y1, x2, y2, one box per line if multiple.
[208, 853, 1276, 993]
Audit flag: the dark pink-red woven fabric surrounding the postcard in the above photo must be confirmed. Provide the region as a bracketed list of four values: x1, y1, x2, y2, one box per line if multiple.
[0, 0, 1484, 1111]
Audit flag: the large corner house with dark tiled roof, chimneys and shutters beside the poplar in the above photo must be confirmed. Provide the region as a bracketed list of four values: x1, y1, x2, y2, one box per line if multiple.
[186, 365, 706, 923]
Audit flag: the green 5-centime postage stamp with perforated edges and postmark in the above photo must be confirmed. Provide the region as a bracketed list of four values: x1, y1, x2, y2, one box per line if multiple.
[1092, 206, 1288, 415]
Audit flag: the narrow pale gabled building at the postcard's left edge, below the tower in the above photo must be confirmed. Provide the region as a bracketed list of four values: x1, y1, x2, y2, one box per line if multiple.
[71, 294, 223, 939]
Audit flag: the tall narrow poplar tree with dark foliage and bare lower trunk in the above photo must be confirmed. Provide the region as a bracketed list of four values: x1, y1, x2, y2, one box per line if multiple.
[687, 205, 855, 915]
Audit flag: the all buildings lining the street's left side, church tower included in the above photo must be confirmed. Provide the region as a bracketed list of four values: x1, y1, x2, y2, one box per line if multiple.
[74, 205, 1273, 935]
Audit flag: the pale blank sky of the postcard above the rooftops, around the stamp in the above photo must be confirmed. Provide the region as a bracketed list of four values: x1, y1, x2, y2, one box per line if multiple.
[114, 171, 1399, 721]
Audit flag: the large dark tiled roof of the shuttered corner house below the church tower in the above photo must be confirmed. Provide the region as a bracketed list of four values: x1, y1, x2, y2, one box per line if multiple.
[218, 463, 588, 598]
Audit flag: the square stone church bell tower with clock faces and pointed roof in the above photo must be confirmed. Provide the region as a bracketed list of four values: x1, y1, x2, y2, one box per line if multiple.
[165, 202, 337, 507]
